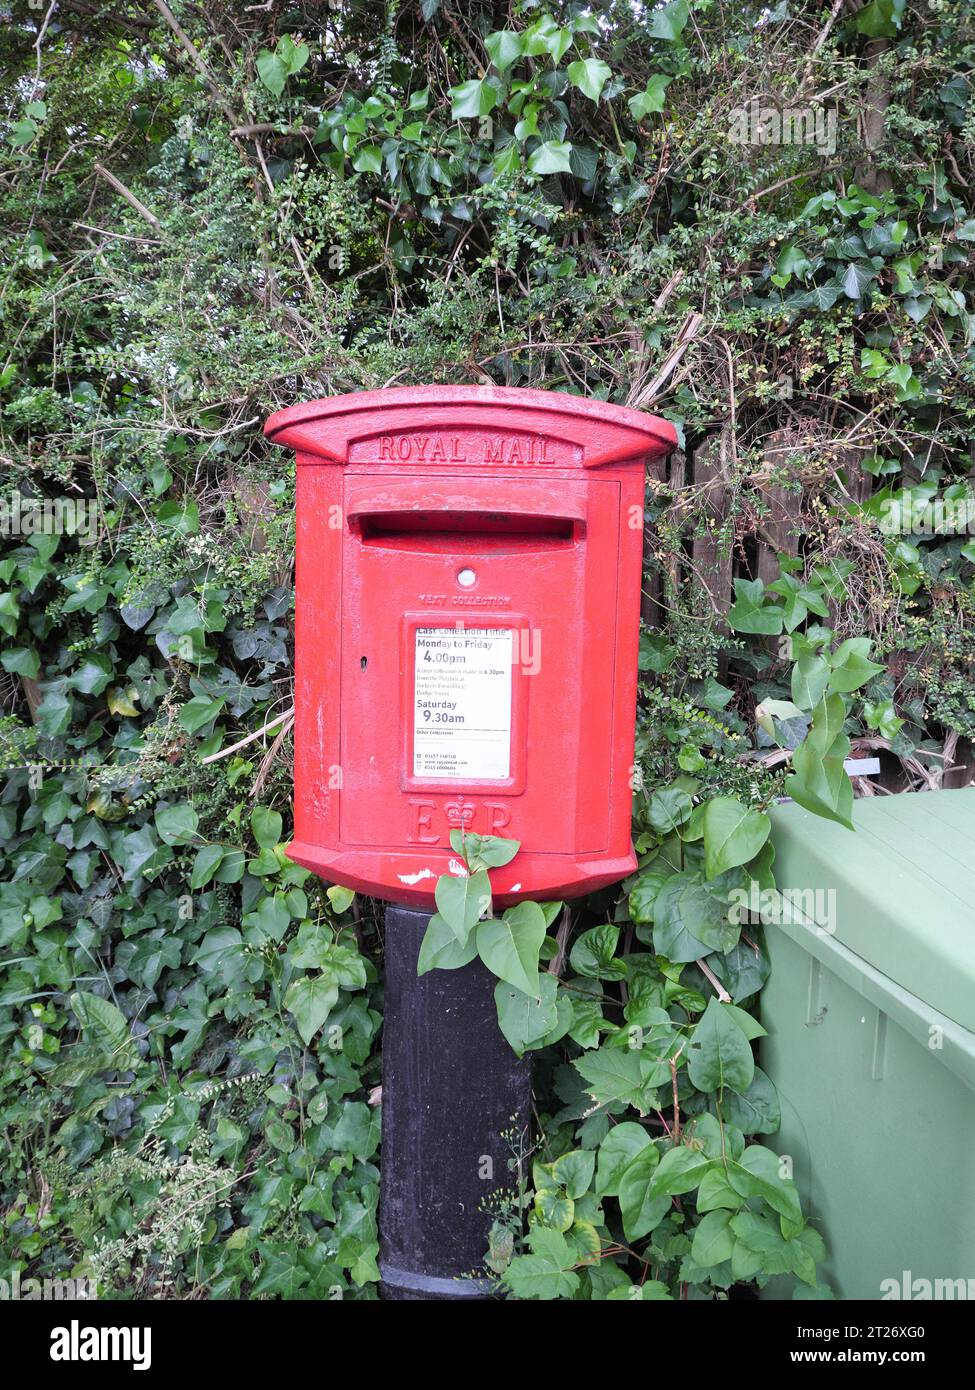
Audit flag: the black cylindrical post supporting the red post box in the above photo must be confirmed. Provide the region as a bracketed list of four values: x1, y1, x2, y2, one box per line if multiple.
[380, 905, 531, 1301]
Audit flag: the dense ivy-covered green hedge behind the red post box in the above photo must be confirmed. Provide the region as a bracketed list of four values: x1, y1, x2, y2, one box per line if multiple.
[0, 0, 975, 1298]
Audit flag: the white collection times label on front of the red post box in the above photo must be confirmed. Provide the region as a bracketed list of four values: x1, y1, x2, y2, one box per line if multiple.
[413, 627, 513, 781]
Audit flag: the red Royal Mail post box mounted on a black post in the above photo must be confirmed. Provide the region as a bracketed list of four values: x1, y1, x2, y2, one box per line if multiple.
[266, 386, 676, 906]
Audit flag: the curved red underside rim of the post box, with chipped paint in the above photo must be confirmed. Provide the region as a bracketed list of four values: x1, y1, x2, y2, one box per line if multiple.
[288, 840, 637, 912]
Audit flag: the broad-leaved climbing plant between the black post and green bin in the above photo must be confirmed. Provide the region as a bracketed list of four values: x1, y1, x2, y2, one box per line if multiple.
[417, 617, 883, 1300]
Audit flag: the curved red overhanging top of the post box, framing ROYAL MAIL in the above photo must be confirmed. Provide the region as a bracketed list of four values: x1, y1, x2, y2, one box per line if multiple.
[264, 385, 677, 468]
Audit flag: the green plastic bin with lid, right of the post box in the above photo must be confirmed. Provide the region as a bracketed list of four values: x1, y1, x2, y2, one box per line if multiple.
[761, 790, 975, 1300]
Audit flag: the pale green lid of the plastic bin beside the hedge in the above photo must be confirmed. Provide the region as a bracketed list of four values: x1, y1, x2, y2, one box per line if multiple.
[768, 788, 975, 1033]
